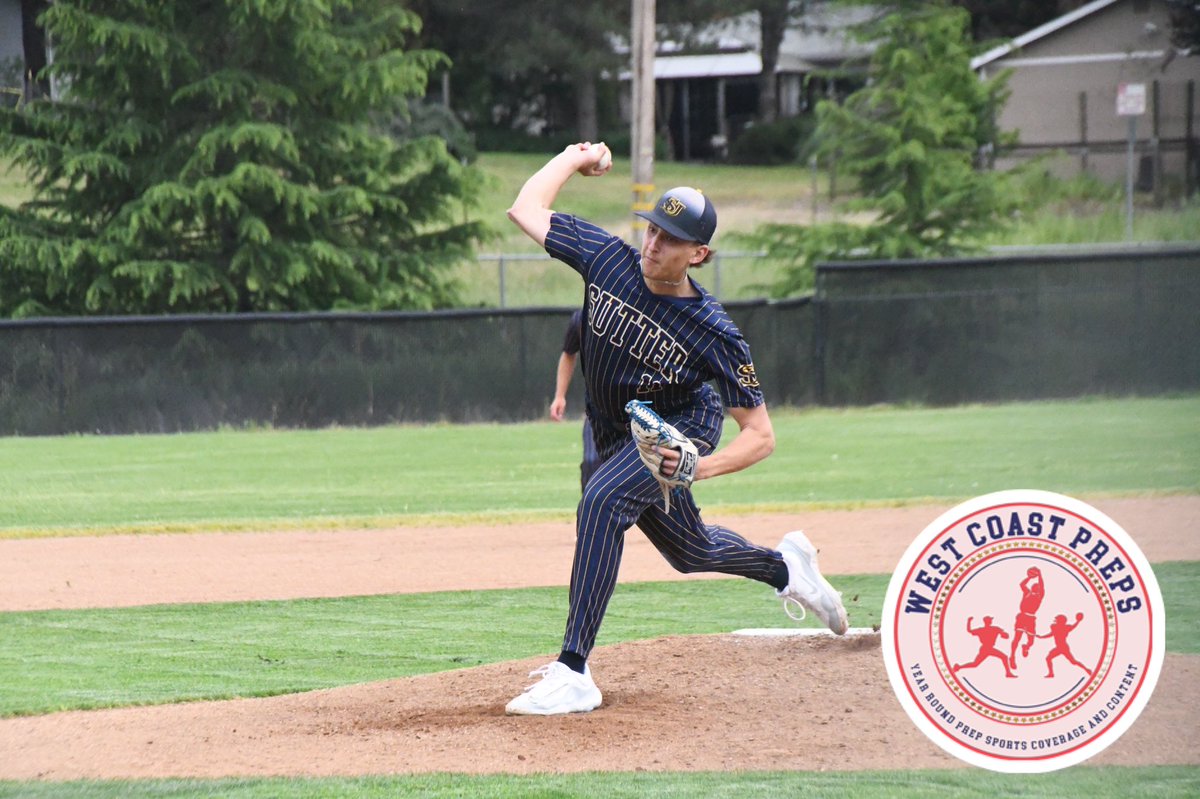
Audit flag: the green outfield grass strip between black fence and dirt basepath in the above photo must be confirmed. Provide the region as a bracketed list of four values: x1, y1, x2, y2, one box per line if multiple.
[0, 396, 1200, 537]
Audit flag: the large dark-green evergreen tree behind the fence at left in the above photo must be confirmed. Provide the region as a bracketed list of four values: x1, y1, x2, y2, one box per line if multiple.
[0, 0, 481, 317]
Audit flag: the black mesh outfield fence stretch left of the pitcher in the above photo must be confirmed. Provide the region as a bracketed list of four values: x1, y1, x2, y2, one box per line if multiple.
[0, 310, 595, 434]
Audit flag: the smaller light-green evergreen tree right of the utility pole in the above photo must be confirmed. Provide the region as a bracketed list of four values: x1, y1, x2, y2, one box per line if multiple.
[755, 4, 1015, 295]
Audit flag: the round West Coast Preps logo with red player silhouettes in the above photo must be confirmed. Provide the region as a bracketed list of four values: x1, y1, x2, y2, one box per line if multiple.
[882, 491, 1164, 773]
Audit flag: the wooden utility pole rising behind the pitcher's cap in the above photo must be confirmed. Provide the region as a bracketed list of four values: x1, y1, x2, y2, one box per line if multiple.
[629, 0, 655, 246]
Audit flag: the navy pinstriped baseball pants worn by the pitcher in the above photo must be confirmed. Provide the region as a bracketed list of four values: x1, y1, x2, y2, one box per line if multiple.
[563, 405, 781, 657]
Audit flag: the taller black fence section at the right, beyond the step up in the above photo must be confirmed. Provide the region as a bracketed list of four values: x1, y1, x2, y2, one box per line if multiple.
[814, 246, 1200, 404]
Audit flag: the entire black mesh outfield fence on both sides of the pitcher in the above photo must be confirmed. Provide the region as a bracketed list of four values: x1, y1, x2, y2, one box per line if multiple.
[0, 247, 1200, 435]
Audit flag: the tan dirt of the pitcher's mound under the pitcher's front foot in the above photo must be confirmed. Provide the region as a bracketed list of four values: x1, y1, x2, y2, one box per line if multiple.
[0, 633, 1200, 780]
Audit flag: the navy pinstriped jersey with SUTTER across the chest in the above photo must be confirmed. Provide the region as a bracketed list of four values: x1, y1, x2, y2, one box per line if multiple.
[546, 214, 763, 451]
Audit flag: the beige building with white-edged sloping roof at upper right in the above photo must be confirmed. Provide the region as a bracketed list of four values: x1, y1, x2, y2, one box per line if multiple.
[972, 0, 1200, 198]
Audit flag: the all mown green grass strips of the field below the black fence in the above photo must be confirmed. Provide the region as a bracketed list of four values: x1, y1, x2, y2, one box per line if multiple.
[0, 396, 1200, 798]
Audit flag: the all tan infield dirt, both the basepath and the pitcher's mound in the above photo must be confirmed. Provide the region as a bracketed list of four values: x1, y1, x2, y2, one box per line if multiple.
[0, 497, 1200, 780]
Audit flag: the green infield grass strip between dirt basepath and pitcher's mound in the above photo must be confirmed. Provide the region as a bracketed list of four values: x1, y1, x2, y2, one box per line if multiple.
[0, 561, 1200, 716]
